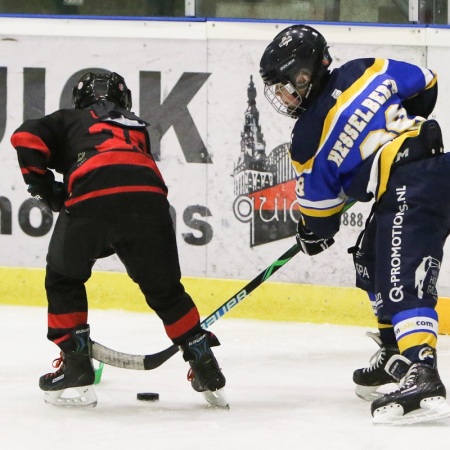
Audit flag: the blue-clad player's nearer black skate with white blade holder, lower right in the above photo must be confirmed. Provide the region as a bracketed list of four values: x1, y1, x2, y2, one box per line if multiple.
[371, 348, 450, 425]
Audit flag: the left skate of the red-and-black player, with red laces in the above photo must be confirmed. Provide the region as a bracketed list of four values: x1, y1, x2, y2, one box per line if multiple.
[39, 325, 97, 406]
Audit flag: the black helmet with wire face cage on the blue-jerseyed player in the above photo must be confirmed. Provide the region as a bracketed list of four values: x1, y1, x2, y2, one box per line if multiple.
[259, 25, 332, 118]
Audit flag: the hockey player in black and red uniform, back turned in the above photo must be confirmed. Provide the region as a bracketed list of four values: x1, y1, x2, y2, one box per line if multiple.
[11, 72, 227, 406]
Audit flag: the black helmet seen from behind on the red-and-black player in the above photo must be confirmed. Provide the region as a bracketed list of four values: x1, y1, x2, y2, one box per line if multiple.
[72, 72, 132, 111]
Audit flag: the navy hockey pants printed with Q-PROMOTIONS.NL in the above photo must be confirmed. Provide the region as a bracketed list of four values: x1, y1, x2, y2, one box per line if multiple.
[354, 153, 450, 322]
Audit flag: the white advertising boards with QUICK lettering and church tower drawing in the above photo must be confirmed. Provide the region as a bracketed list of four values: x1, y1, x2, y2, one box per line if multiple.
[0, 19, 450, 287]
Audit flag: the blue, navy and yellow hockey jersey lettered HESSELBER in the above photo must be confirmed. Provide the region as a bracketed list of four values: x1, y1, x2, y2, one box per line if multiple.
[291, 58, 437, 237]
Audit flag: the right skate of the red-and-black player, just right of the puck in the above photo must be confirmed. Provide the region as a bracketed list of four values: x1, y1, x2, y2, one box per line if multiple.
[182, 331, 228, 407]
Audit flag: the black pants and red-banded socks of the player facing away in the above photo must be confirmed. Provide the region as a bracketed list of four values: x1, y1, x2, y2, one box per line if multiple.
[45, 195, 201, 351]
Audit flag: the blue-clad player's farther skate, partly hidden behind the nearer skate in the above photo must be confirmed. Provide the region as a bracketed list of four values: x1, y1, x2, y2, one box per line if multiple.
[353, 331, 399, 401]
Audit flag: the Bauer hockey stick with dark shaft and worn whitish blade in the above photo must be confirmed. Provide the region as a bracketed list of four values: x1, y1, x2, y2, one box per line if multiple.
[91, 199, 356, 370]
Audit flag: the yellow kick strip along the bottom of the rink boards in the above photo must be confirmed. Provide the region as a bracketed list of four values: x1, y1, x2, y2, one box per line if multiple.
[0, 267, 450, 334]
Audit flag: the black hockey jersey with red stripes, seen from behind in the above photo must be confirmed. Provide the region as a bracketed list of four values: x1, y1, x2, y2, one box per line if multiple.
[11, 101, 167, 212]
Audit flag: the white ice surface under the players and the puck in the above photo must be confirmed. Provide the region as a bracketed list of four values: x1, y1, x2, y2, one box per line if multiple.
[0, 306, 450, 450]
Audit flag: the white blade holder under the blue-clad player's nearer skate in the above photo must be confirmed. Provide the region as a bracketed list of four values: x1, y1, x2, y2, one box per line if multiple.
[373, 397, 450, 425]
